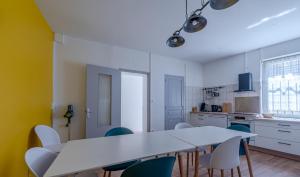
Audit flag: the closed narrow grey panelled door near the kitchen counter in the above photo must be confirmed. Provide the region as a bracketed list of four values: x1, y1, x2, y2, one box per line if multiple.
[165, 75, 184, 130]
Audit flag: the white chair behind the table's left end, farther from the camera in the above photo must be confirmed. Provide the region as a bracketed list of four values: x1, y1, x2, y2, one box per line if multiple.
[34, 125, 64, 153]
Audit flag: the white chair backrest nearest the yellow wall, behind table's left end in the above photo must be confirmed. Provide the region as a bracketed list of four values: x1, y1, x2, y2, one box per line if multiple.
[34, 125, 61, 147]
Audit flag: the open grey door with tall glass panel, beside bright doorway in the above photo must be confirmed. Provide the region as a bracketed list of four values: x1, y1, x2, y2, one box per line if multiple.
[86, 65, 121, 138]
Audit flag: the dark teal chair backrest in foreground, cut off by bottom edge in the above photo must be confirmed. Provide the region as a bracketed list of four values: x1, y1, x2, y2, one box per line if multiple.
[121, 157, 175, 177]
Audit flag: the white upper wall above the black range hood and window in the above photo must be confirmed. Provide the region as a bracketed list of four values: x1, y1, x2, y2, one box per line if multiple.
[203, 38, 300, 87]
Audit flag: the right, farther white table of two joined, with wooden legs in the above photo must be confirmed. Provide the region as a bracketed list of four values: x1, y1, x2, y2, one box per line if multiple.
[166, 126, 256, 177]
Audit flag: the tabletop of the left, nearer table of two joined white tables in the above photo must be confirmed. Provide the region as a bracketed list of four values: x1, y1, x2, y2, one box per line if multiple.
[44, 131, 195, 177]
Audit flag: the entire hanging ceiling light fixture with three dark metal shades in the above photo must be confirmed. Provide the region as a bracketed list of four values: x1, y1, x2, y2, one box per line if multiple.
[167, 0, 239, 47]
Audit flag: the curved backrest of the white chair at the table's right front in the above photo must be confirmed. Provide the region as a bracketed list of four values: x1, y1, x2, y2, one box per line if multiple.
[210, 136, 242, 170]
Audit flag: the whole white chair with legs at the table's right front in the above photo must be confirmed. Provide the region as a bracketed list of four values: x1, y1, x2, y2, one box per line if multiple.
[200, 136, 242, 177]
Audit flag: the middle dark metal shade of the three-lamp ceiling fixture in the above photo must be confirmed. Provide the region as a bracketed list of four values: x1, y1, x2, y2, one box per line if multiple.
[183, 13, 207, 33]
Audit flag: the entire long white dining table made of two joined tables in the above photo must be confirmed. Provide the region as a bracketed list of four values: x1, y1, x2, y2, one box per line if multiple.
[44, 126, 255, 177]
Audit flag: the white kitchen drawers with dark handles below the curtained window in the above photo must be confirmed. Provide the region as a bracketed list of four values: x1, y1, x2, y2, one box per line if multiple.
[255, 120, 300, 155]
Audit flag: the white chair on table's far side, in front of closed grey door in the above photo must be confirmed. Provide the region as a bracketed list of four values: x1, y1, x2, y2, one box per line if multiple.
[174, 122, 206, 176]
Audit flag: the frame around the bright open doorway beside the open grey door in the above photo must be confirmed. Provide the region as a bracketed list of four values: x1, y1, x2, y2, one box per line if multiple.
[119, 68, 151, 132]
